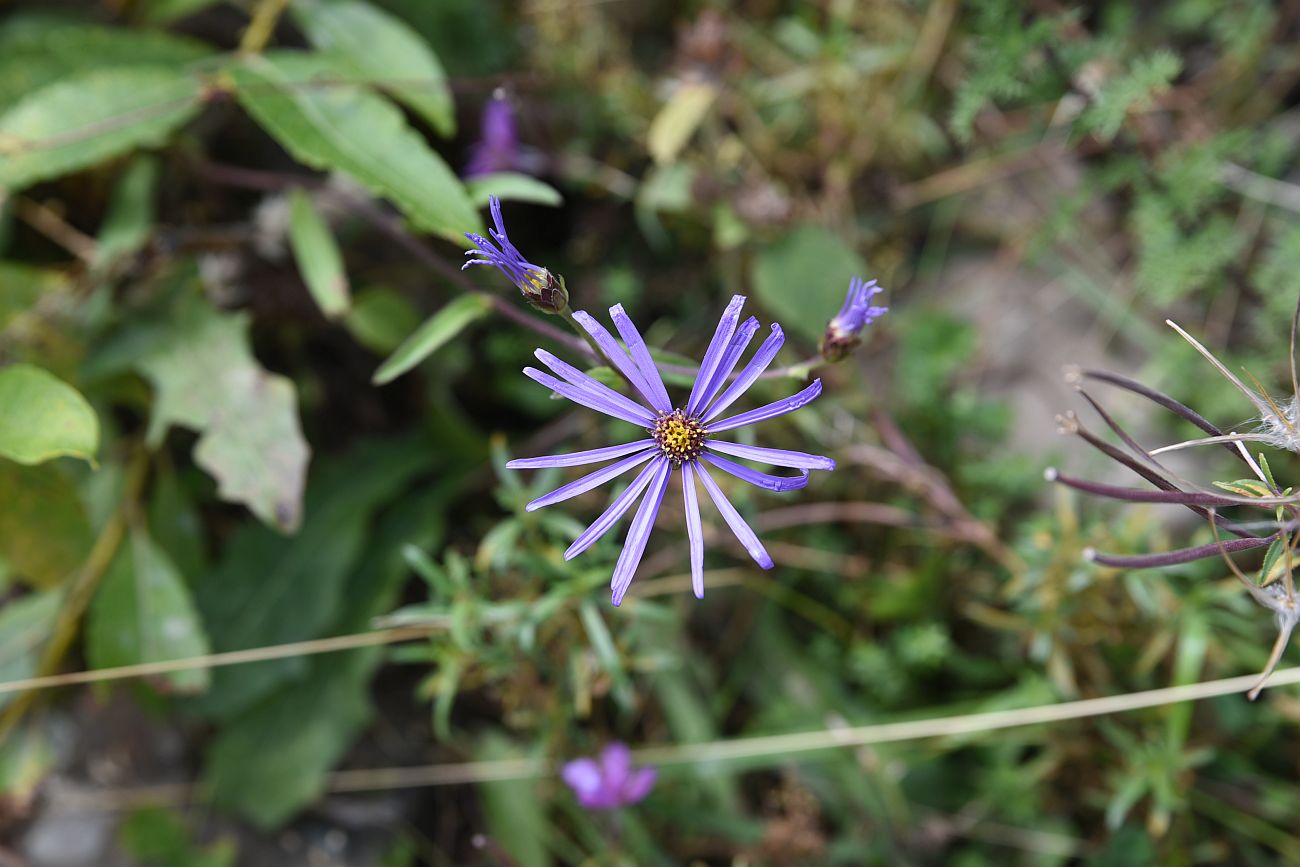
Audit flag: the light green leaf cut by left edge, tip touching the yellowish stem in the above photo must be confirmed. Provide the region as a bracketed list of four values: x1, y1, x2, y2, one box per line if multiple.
[0, 66, 203, 190]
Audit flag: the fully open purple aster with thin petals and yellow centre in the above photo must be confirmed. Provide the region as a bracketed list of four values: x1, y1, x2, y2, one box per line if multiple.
[506, 295, 835, 604]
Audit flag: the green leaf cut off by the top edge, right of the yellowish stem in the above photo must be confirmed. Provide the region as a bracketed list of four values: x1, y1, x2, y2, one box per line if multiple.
[293, 0, 456, 138]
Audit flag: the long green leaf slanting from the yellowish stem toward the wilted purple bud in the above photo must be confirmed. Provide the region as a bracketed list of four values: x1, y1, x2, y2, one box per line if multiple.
[229, 52, 482, 243]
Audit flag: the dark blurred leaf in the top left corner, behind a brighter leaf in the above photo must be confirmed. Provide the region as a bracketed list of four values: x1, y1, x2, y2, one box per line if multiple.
[0, 15, 215, 112]
